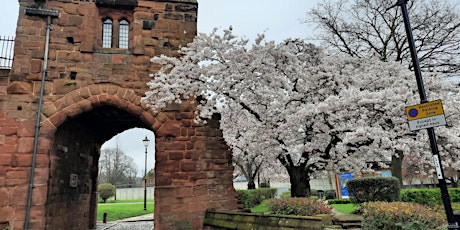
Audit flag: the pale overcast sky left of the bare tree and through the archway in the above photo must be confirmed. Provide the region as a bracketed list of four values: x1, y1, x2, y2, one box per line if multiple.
[0, 0, 319, 175]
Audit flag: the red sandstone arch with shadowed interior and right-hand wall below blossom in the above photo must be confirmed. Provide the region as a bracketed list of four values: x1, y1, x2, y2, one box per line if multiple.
[42, 85, 236, 229]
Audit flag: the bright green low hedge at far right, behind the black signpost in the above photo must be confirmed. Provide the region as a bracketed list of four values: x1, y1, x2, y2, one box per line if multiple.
[401, 188, 460, 206]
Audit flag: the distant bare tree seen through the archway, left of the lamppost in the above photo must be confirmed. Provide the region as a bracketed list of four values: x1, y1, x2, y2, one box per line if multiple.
[99, 147, 137, 185]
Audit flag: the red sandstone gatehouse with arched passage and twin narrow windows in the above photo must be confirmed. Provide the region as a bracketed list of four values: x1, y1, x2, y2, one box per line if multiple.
[0, 0, 236, 229]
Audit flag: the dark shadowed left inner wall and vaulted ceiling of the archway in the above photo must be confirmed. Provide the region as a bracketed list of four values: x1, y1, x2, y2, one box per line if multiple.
[46, 105, 148, 229]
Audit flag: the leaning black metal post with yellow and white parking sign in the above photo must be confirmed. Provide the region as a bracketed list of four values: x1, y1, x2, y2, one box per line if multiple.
[395, 0, 459, 229]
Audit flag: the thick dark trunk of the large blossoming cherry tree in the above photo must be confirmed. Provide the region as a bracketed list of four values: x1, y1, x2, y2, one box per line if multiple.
[286, 165, 311, 197]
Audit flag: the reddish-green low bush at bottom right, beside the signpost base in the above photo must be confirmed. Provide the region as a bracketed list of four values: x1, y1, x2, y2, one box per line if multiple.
[361, 202, 445, 230]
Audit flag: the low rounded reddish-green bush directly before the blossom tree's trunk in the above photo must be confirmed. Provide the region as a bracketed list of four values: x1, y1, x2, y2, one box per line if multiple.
[266, 198, 332, 216]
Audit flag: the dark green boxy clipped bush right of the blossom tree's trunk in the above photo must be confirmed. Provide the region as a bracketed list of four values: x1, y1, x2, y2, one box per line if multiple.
[347, 177, 401, 204]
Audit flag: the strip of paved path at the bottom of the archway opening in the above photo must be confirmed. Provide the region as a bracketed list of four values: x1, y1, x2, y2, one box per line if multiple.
[96, 213, 153, 230]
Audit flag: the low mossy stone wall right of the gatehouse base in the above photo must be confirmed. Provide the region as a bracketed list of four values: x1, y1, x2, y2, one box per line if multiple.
[203, 210, 332, 230]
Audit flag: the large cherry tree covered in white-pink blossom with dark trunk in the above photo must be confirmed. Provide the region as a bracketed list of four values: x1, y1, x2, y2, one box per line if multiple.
[143, 29, 460, 197]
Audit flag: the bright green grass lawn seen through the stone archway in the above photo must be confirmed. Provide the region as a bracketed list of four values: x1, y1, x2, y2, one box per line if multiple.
[97, 201, 153, 221]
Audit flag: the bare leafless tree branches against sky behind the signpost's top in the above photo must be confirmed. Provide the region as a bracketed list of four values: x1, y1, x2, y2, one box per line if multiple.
[305, 0, 460, 73]
